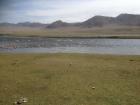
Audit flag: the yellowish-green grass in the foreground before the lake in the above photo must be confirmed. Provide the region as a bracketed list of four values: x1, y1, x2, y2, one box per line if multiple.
[0, 54, 140, 105]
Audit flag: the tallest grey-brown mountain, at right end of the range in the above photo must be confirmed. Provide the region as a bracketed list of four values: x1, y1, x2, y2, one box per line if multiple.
[81, 14, 140, 27]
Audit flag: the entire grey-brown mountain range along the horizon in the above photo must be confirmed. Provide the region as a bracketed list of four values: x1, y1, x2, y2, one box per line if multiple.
[0, 14, 140, 29]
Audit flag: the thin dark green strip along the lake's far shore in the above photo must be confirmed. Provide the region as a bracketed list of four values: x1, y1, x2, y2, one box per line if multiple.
[0, 34, 140, 39]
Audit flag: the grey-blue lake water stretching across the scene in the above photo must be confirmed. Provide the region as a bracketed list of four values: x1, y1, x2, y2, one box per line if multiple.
[0, 36, 140, 55]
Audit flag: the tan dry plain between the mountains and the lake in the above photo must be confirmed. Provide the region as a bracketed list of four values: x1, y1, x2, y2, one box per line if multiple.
[0, 26, 140, 38]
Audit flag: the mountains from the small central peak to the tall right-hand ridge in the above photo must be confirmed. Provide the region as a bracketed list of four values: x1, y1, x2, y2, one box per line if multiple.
[47, 14, 140, 28]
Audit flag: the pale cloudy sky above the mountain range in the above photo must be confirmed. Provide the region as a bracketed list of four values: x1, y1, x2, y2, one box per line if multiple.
[0, 0, 140, 23]
